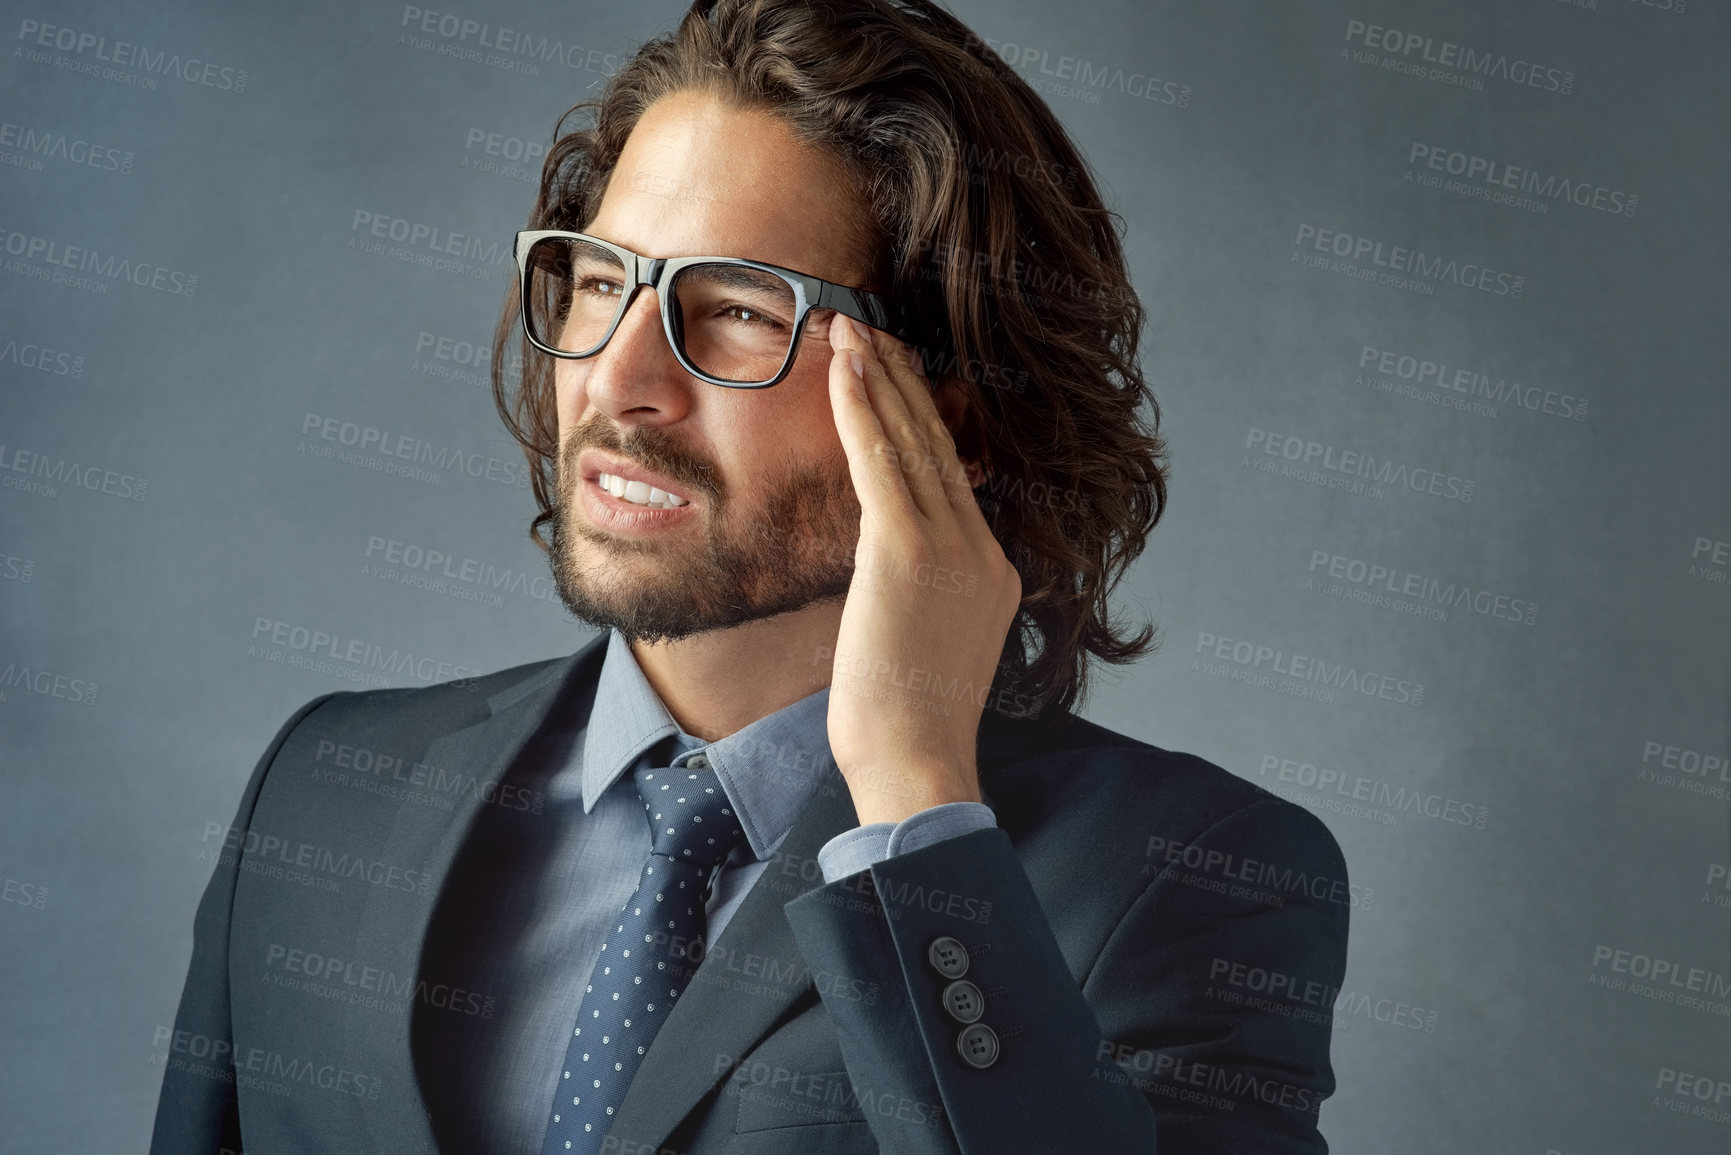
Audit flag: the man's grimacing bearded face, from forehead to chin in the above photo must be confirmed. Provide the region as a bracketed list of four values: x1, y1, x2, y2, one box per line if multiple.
[552, 92, 871, 642]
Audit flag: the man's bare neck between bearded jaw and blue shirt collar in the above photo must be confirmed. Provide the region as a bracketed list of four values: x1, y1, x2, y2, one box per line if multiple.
[632, 601, 841, 741]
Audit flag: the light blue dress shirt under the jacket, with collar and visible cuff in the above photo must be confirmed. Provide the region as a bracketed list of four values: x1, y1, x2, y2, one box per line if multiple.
[443, 630, 997, 1155]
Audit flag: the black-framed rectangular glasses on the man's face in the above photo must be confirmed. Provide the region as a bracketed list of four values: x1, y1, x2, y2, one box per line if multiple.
[516, 229, 914, 390]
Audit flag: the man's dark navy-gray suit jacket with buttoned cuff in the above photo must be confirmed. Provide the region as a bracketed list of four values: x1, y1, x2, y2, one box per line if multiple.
[151, 639, 1355, 1155]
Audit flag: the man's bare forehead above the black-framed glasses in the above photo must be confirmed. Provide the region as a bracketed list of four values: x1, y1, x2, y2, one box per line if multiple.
[587, 90, 872, 287]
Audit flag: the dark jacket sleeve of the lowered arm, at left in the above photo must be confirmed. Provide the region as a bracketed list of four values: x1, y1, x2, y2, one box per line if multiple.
[151, 691, 350, 1155]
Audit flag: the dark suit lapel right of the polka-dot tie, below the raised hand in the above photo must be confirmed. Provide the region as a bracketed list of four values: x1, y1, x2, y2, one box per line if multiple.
[609, 776, 859, 1150]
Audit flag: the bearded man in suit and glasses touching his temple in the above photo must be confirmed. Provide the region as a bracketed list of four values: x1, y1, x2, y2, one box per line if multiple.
[152, 0, 1350, 1155]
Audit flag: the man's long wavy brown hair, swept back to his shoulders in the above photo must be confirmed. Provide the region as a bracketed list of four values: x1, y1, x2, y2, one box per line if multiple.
[492, 0, 1167, 713]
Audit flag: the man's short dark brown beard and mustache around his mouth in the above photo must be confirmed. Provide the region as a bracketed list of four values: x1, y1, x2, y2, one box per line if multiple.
[550, 414, 860, 644]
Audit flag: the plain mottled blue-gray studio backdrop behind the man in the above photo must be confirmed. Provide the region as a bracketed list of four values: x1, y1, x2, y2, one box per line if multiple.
[0, 0, 1731, 1155]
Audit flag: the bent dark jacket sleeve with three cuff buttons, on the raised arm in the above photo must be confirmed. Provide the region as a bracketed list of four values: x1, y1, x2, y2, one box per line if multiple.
[784, 797, 1352, 1155]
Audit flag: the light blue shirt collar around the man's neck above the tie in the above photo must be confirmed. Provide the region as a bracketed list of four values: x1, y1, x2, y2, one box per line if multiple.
[583, 630, 841, 861]
